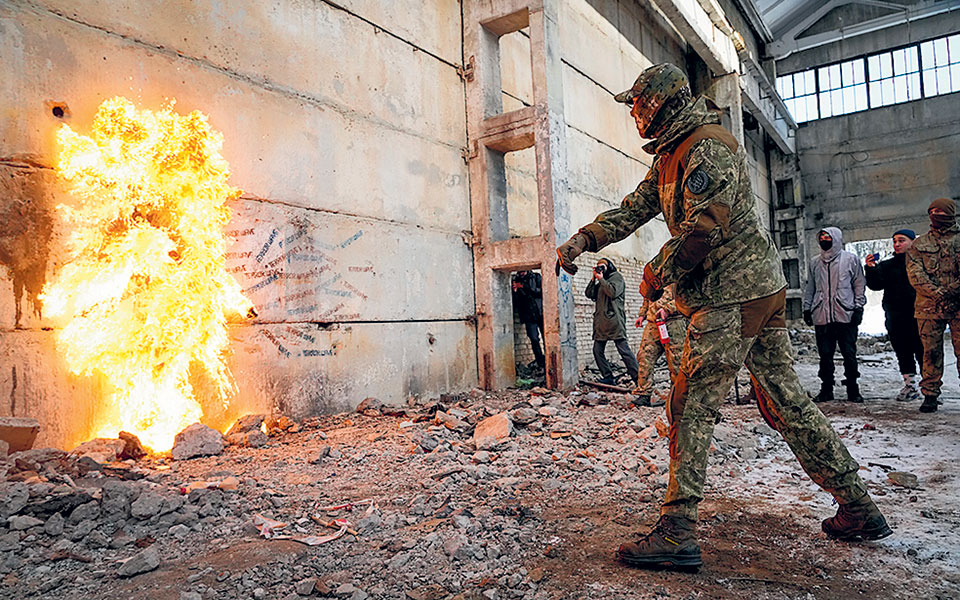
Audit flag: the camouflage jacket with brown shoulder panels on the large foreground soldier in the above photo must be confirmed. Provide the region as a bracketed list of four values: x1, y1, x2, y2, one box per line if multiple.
[580, 97, 786, 315]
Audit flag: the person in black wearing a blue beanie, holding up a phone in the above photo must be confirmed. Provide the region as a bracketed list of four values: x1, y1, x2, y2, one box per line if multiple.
[864, 229, 923, 402]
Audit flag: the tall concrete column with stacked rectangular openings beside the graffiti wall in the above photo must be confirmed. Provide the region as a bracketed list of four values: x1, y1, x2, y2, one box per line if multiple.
[464, 0, 578, 389]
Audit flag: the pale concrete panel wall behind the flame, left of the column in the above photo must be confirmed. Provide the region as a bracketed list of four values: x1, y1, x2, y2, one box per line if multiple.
[0, 0, 477, 446]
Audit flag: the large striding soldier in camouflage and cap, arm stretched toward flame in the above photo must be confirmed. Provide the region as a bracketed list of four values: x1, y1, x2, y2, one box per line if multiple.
[557, 65, 891, 568]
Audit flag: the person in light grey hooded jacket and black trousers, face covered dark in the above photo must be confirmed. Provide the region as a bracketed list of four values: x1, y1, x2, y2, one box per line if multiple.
[803, 227, 867, 402]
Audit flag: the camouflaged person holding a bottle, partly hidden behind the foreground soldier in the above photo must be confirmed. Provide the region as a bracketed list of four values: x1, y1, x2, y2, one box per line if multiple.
[633, 285, 689, 406]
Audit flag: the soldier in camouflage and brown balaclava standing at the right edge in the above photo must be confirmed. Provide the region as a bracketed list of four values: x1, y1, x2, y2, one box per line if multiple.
[907, 198, 960, 412]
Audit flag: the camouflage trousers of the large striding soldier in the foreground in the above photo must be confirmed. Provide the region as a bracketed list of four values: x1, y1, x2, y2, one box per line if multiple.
[661, 290, 867, 520]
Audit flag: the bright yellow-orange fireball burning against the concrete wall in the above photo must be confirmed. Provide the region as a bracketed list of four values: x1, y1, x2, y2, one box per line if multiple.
[43, 97, 256, 452]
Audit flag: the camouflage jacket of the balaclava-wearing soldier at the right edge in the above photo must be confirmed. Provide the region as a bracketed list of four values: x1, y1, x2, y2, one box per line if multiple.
[907, 225, 960, 319]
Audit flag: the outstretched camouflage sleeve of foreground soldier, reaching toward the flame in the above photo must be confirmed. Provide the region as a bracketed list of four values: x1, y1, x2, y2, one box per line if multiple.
[580, 157, 660, 252]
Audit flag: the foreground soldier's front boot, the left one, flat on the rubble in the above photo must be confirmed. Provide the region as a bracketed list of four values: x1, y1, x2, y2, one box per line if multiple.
[617, 515, 703, 571]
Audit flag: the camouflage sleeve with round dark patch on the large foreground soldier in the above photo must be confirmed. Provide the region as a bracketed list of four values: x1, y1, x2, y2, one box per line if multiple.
[650, 139, 739, 284]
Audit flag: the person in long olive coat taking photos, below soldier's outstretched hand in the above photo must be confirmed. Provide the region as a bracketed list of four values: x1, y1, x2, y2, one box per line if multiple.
[584, 258, 639, 385]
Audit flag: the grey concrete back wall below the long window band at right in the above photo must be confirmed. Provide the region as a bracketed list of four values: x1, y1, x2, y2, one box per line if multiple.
[797, 94, 960, 246]
